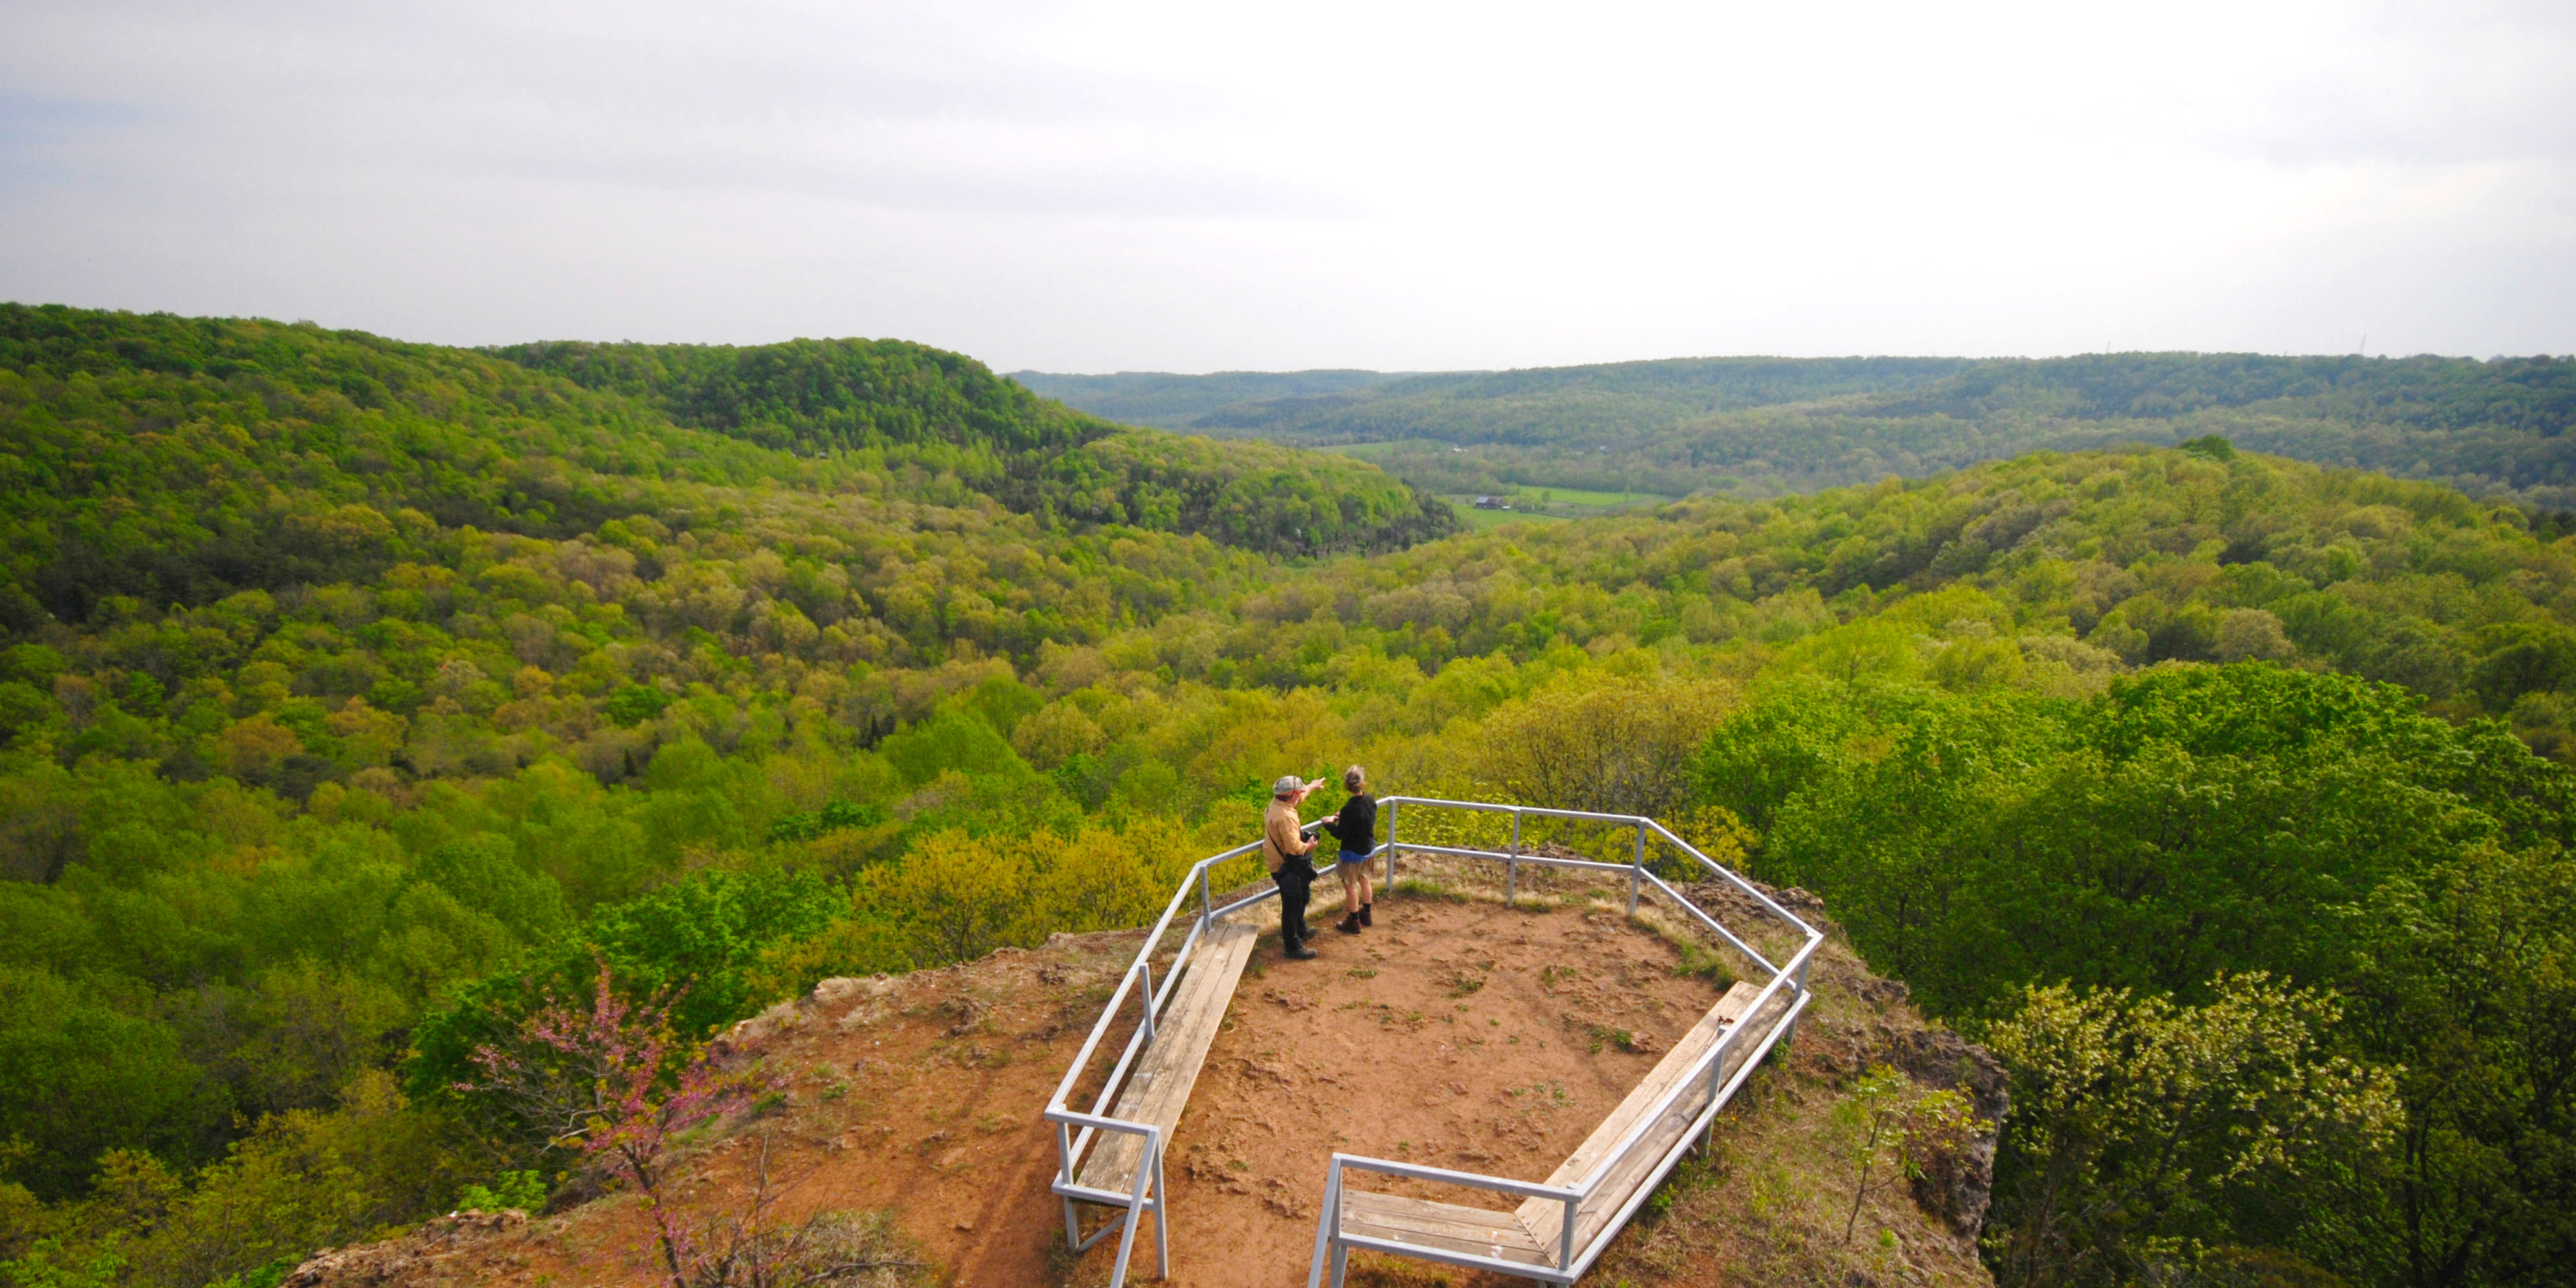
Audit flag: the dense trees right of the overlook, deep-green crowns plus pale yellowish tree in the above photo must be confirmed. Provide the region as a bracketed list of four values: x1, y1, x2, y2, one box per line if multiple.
[1703, 680, 2576, 1283]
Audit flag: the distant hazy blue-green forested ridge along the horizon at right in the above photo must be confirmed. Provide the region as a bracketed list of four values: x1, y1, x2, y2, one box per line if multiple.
[1059, 353, 2576, 507]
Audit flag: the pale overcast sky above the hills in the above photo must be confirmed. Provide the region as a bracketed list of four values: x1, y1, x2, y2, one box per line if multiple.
[0, 0, 2576, 371]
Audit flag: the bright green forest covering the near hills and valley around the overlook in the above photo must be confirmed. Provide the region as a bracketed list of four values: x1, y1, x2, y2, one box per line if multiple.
[0, 309, 2576, 1288]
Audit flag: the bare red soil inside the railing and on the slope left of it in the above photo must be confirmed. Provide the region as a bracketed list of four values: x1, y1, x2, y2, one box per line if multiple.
[322, 896, 1721, 1288]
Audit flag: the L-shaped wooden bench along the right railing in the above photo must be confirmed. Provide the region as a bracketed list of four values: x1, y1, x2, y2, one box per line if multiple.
[1316, 981, 1788, 1275]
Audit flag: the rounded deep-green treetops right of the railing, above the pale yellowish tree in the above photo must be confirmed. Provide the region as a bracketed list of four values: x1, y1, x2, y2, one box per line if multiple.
[1705, 665, 2568, 1015]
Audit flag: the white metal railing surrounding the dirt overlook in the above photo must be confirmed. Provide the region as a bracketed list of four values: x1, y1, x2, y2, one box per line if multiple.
[1046, 796, 1824, 1288]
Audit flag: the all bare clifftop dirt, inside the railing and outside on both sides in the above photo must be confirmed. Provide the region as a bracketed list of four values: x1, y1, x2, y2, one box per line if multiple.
[291, 866, 1991, 1288]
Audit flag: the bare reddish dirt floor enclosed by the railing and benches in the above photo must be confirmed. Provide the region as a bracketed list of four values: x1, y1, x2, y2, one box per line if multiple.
[1167, 896, 1726, 1288]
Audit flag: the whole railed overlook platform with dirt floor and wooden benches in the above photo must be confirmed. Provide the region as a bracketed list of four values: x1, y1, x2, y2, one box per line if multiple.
[1046, 799, 1821, 1283]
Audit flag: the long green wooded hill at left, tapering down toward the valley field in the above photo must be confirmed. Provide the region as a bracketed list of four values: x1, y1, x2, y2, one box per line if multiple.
[0, 304, 1455, 634]
